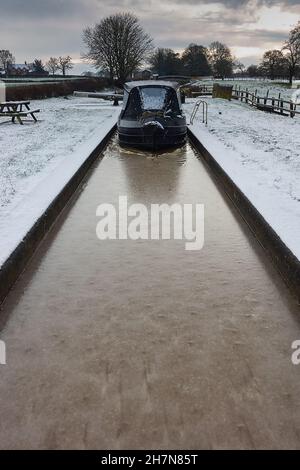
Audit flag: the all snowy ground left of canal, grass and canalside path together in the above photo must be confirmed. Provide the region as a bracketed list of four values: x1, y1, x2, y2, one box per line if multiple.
[0, 97, 120, 266]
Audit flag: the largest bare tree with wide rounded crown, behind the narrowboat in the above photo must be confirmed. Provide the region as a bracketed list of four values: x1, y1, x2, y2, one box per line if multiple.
[83, 13, 153, 83]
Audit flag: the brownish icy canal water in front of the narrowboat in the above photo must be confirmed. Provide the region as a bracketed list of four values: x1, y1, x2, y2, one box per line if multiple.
[0, 139, 300, 449]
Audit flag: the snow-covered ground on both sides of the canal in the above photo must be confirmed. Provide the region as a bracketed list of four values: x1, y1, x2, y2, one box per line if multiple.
[0, 90, 300, 266]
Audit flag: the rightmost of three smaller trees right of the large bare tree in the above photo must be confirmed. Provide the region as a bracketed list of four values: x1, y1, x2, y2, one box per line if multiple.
[208, 41, 234, 79]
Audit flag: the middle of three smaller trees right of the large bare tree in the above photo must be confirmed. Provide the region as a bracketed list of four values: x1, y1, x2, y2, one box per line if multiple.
[181, 44, 211, 76]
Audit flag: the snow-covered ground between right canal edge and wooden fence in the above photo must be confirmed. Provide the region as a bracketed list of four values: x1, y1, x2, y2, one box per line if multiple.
[185, 98, 300, 259]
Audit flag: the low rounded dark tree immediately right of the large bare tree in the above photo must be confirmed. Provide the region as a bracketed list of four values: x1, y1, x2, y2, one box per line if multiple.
[149, 48, 183, 75]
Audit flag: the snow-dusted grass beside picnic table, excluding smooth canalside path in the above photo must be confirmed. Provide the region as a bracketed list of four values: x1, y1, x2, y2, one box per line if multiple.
[0, 97, 118, 216]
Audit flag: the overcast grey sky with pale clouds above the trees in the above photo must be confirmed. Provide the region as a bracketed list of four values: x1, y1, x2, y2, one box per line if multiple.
[0, 0, 300, 72]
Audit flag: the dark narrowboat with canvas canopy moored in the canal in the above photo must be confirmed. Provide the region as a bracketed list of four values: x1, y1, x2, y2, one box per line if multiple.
[118, 80, 187, 150]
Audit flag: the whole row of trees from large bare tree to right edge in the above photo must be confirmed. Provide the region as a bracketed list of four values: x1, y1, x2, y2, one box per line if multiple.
[83, 13, 300, 84]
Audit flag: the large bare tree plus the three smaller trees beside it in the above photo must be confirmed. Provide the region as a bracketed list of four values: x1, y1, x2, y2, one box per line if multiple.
[83, 13, 235, 84]
